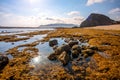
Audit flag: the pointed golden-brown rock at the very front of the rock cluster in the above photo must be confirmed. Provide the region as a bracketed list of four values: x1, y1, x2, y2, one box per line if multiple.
[58, 51, 71, 66]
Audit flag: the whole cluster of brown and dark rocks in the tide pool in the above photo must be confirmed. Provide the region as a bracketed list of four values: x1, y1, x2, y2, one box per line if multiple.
[48, 40, 98, 65]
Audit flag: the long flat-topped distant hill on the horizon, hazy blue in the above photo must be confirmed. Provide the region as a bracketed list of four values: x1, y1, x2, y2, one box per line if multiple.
[39, 23, 76, 28]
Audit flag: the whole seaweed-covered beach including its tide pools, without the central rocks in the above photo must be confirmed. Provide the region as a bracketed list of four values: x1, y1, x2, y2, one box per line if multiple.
[0, 25, 120, 80]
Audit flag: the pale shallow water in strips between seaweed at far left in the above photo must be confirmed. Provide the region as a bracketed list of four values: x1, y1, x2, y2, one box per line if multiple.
[0, 28, 54, 53]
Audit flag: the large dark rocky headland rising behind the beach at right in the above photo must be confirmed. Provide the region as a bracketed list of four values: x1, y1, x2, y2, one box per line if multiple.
[80, 13, 115, 27]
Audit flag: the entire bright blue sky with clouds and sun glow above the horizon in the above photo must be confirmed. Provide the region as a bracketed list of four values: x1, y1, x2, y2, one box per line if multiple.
[0, 0, 120, 27]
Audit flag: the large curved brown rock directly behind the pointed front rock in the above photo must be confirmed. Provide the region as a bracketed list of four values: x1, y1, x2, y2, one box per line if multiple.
[55, 44, 71, 55]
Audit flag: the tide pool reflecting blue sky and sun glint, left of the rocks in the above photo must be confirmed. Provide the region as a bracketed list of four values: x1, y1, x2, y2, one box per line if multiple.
[30, 38, 65, 67]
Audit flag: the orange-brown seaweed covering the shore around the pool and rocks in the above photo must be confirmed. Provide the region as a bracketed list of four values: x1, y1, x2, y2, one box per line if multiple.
[0, 25, 120, 80]
